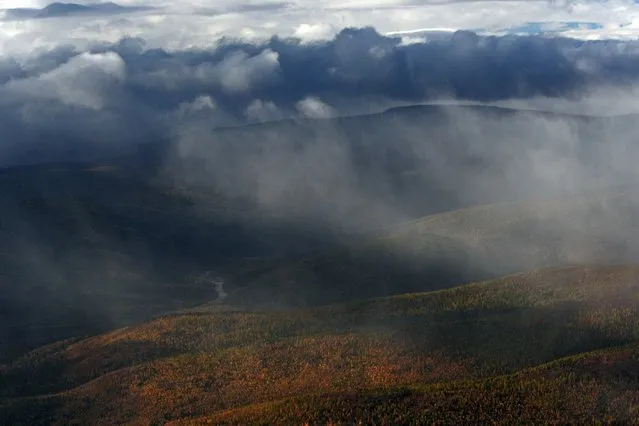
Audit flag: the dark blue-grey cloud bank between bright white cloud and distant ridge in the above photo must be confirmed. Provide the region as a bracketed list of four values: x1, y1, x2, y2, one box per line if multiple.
[0, 28, 639, 164]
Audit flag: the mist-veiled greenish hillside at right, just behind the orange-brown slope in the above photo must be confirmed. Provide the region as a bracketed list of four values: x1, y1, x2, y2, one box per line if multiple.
[231, 188, 639, 306]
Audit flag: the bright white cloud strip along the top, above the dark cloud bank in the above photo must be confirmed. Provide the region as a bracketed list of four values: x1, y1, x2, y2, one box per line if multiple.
[0, 0, 639, 59]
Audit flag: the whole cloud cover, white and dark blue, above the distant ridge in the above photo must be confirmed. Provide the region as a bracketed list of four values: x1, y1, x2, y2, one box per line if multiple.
[0, 1, 639, 205]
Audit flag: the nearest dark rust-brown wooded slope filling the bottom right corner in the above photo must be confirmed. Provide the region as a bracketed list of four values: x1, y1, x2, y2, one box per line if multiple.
[195, 344, 639, 425]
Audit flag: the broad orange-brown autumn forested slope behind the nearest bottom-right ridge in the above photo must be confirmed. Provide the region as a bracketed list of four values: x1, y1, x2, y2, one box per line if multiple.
[0, 266, 639, 424]
